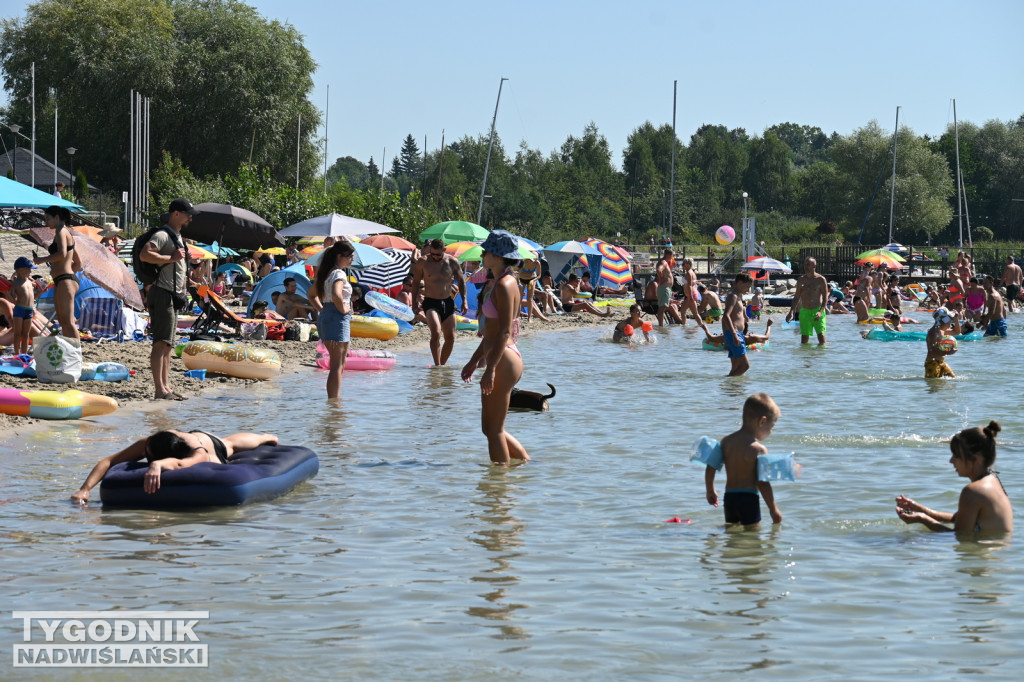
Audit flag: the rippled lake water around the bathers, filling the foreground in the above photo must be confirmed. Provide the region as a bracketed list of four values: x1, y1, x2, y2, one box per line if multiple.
[0, 313, 1024, 680]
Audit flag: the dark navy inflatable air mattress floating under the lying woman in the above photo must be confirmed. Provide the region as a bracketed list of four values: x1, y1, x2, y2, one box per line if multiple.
[99, 445, 319, 509]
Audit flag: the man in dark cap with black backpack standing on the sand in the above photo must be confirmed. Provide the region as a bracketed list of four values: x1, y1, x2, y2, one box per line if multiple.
[136, 199, 199, 400]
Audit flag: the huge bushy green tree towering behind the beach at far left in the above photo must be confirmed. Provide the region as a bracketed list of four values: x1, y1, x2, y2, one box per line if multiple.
[0, 0, 319, 185]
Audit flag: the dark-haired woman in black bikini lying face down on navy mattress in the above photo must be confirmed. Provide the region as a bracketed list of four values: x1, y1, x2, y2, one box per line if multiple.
[71, 430, 278, 505]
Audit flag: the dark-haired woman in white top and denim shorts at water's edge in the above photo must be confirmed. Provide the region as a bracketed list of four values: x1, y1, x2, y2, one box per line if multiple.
[307, 240, 355, 398]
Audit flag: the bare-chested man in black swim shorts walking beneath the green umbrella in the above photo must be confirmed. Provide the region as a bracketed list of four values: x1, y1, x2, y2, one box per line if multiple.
[413, 240, 469, 365]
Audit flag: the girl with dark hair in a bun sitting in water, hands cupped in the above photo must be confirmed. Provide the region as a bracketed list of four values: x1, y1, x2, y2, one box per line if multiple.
[896, 421, 1014, 532]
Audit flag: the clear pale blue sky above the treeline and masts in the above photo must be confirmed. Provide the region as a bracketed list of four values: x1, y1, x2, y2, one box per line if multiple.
[4, 0, 1024, 167]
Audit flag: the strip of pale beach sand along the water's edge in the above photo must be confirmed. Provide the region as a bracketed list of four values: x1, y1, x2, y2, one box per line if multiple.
[0, 308, 626, 436]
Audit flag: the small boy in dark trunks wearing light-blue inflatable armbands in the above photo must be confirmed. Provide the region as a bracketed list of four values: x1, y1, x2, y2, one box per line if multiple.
[705, 393, 782, 528]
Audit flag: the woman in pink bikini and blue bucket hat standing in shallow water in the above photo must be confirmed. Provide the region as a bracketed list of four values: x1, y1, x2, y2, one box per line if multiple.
[462, 229, 529, 465]
